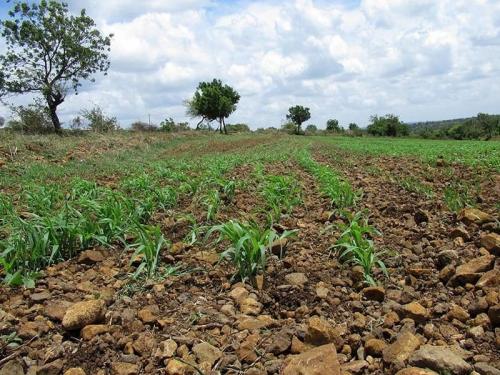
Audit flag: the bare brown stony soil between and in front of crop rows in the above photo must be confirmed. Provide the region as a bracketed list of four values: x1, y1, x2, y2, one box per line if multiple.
[0, 149, 500, 375]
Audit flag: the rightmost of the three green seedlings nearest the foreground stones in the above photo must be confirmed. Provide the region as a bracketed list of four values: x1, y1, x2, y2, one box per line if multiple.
[334, 212, 388, 285]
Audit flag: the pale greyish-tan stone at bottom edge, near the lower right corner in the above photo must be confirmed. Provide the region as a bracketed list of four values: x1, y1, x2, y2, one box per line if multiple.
[409, 345, 472, 375]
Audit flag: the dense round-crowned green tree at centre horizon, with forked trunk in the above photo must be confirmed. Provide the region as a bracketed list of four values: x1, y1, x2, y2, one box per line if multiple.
[186, 79, 240, 134]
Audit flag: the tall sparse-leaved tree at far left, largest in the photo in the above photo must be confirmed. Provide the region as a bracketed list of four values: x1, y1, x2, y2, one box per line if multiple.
[0, 0, 112, 133]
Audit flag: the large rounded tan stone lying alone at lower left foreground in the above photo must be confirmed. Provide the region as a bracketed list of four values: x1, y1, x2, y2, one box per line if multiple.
[62, 300, 106, 331]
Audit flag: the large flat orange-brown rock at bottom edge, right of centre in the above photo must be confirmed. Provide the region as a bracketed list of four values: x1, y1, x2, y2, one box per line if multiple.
[280, 344, 340, 375]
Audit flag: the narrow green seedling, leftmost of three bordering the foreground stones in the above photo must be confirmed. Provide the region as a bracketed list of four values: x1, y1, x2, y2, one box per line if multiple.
[130, 224, 167, 279]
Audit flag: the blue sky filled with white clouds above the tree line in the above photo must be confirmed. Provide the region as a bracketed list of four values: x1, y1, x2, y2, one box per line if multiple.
[0, 0, 500, 129]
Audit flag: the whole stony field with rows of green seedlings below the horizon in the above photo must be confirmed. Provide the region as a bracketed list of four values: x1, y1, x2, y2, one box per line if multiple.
[0, 132, 500, 375]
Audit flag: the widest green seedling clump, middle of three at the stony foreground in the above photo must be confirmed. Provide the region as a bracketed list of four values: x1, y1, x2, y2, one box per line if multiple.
[207, 220, 296, 282]
